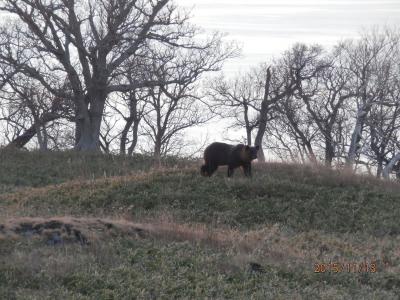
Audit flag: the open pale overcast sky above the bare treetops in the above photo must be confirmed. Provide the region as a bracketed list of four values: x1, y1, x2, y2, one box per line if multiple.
[175, 0, 400, 73]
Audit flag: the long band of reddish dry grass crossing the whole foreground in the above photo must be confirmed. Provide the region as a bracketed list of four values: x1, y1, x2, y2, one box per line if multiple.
[0, 215, 400, 274]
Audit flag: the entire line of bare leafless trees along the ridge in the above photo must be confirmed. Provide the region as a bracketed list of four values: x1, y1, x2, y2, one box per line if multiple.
[0, 0, 400, 177]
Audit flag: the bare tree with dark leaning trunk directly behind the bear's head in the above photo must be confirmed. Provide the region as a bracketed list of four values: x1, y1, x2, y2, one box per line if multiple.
[210, 56, 296, 161]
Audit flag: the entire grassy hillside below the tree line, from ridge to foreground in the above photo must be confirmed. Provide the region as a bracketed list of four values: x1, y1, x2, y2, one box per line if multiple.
[0, 152, 400, 299]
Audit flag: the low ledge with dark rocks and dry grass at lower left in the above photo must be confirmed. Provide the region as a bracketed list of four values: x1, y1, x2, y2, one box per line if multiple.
[0, 217, 249, 248]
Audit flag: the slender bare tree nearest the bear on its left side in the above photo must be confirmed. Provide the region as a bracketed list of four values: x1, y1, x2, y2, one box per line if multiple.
[143, 41, 235, 158]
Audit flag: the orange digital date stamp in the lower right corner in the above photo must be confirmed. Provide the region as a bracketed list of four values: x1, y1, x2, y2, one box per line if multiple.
[314, 261, 378, 273]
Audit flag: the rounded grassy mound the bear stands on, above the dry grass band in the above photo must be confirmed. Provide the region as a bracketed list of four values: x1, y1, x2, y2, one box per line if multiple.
[0, 164, 400, 236]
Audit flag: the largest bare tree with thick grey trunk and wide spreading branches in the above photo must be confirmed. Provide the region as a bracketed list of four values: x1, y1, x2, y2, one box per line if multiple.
[0, 0, 234, 150]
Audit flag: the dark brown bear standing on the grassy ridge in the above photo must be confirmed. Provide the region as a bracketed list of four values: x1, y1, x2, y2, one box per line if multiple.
[200, 142, 259, 177]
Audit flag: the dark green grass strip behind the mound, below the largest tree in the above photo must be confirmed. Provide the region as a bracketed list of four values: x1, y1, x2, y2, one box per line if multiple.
[0, 149, 189, 192]
